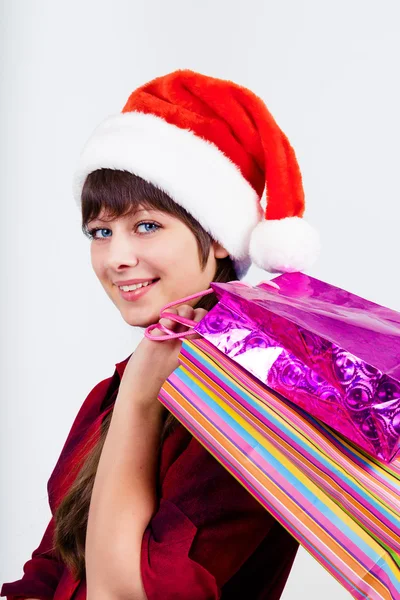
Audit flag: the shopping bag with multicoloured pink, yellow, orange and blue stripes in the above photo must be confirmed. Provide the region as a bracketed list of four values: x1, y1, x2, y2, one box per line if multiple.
[159, 339, 400, 600]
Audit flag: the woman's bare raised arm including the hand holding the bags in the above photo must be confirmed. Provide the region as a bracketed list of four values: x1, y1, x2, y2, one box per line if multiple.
[85, 305, 205, 600]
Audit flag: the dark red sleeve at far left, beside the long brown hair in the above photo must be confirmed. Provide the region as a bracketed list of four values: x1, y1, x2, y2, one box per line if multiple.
[0, 372, 115, 600]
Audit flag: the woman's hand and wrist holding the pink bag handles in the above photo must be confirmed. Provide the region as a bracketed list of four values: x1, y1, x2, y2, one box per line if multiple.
[120, 304, 207, 406]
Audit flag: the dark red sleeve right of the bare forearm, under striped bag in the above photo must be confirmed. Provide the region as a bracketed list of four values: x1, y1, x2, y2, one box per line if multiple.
[141, 438, 284, 600]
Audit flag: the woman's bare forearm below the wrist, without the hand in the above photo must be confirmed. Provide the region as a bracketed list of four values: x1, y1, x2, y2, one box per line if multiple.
[85, 386, 164, 600]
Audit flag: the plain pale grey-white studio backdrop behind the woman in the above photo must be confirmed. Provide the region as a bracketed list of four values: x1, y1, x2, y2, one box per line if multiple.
[0, 0, 400, 600]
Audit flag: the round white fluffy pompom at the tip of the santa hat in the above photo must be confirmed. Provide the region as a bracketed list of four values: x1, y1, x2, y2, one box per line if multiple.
[250, 217, 320, 273]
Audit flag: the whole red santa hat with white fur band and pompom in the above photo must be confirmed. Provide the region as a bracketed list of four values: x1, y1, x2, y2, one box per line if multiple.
[74, 70, 319, 279]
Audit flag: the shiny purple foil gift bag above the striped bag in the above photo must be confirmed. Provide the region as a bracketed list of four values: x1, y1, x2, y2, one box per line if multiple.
[195, 273, 400, 462]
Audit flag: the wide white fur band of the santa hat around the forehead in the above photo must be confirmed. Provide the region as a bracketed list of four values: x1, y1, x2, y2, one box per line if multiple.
[73, 111, 262, 270]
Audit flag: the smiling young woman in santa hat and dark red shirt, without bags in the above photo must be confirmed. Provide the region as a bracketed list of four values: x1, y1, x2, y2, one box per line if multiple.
[1, 71, 318, 600]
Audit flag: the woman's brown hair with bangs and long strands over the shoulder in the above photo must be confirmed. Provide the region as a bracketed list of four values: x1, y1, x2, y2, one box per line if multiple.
[53, 169, 237, 579]
